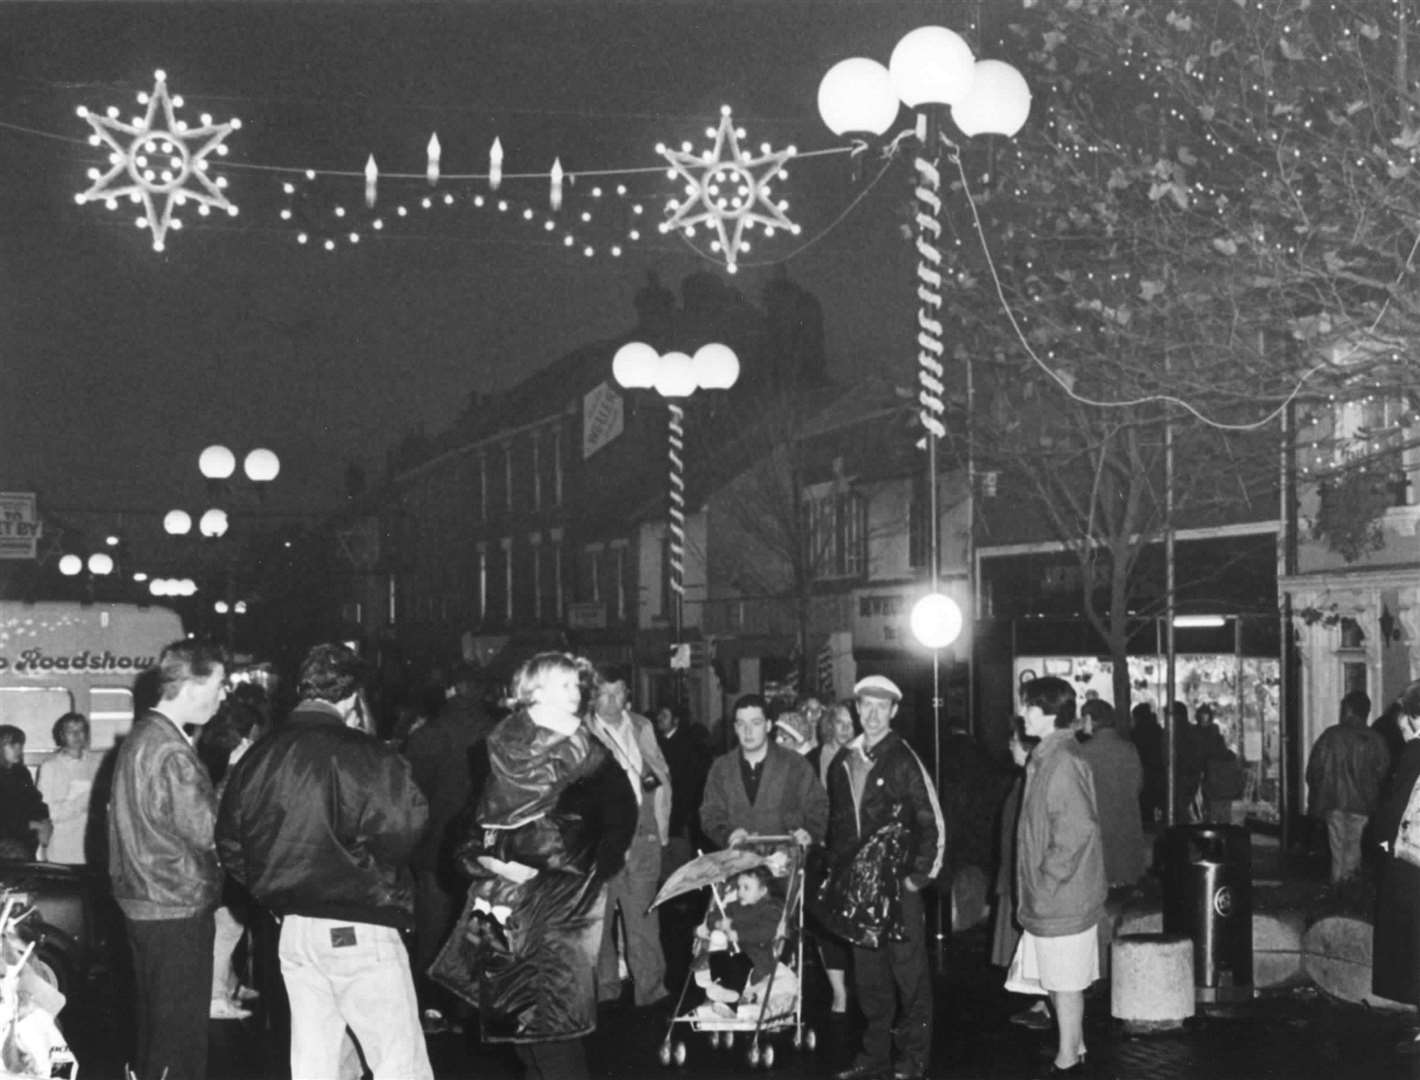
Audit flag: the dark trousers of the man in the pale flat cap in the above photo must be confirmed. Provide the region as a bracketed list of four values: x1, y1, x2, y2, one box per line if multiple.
[853, 887, 932, 1076]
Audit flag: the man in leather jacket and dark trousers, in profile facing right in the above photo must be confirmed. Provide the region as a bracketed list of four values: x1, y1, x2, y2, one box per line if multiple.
[108, 641, 227, 1080]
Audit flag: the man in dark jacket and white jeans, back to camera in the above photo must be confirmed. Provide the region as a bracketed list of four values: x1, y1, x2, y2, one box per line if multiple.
[217, 644, 433, 1080]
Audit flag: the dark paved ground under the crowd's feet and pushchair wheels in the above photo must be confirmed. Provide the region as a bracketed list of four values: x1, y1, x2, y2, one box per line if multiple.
[52, 931, 1420, 1080]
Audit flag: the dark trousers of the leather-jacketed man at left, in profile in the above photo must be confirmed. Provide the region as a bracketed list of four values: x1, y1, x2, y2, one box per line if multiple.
[124, 911, 213, 1080]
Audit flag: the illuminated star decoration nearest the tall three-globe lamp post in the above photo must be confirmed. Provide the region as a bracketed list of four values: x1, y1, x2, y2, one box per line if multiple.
[656, 105, 799, 274]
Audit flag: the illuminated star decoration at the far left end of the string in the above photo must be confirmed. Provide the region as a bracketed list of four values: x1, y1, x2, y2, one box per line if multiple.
[74, 71, 241, 251]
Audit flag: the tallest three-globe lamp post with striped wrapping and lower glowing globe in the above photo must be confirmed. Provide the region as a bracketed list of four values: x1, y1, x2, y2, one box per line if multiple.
[818, 26, 1031, 962]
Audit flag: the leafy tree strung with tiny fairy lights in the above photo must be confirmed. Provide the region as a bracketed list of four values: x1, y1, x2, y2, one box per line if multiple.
[944, 0, 1420, 715]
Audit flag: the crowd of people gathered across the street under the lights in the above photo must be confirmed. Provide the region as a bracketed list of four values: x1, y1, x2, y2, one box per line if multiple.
[13, 640, 1420, 1080]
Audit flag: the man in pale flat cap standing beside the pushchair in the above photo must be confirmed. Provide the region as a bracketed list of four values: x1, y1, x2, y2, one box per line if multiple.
[828, 676, 947, 1080]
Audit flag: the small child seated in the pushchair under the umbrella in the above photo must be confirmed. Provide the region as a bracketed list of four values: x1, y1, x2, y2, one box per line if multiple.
[692, 866, 798, 1019]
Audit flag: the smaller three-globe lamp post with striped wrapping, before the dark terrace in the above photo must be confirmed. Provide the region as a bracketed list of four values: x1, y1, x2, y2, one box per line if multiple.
[612, 341, 740, 701]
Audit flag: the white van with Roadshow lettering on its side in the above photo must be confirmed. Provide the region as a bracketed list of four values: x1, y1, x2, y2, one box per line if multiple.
[0, 600, 183, 768]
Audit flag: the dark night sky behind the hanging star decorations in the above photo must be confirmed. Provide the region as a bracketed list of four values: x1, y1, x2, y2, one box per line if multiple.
[0, 0, 976, 542]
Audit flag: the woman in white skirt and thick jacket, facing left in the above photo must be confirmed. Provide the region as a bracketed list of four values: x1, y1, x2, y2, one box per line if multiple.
[1005, 676, 1109, 1076]
